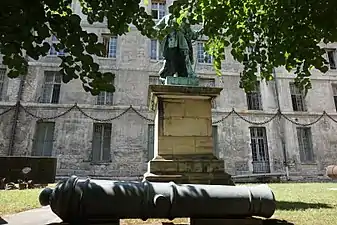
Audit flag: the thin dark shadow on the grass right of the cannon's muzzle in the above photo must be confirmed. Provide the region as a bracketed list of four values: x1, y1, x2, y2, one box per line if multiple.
[276, 201, 332, 210]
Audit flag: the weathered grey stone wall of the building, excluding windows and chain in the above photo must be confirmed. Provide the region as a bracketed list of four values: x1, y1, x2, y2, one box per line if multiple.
[0, 0, 337, 177]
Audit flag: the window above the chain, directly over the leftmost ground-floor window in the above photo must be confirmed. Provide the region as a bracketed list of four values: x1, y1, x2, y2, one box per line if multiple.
[40, 71, 62, 104]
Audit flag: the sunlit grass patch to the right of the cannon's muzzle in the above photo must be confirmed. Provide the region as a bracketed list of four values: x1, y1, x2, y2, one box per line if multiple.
[270, 183, 337, 225]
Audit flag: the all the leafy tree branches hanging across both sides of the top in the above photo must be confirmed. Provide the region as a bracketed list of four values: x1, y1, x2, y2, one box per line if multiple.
[0, 0, 337, 95]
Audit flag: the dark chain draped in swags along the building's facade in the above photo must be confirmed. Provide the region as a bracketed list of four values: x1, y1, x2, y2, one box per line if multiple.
[0, 103, 337, 126]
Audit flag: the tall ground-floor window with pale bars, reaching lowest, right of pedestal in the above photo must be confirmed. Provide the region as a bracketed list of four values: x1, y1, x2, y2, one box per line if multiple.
[249, 127, 270, 173]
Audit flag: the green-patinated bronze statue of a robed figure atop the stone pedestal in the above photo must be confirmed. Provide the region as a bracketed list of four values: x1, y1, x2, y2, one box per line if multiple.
[157, 15, 201, 82]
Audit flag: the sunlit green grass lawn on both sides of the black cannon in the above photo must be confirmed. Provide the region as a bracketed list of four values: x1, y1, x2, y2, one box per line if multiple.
[0, 183, 337, 225]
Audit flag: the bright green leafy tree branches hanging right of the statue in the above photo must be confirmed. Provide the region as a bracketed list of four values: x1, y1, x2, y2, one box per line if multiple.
[172, 0, 337, 94]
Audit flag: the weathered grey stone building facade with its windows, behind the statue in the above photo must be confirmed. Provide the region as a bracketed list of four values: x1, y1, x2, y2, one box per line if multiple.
[0, 1, 337, 178]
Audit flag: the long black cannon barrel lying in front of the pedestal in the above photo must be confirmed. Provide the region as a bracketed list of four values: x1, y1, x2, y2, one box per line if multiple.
[39, 176, 276, 223]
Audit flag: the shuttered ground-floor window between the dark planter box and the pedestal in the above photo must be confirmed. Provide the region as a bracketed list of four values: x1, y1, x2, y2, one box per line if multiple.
[92, 123, 112, 162]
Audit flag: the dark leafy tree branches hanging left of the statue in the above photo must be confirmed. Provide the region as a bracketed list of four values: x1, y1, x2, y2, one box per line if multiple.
[0, 0, 154, 95]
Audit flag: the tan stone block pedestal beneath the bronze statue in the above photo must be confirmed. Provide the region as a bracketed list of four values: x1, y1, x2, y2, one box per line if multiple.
[144, 82, 233, 185]
